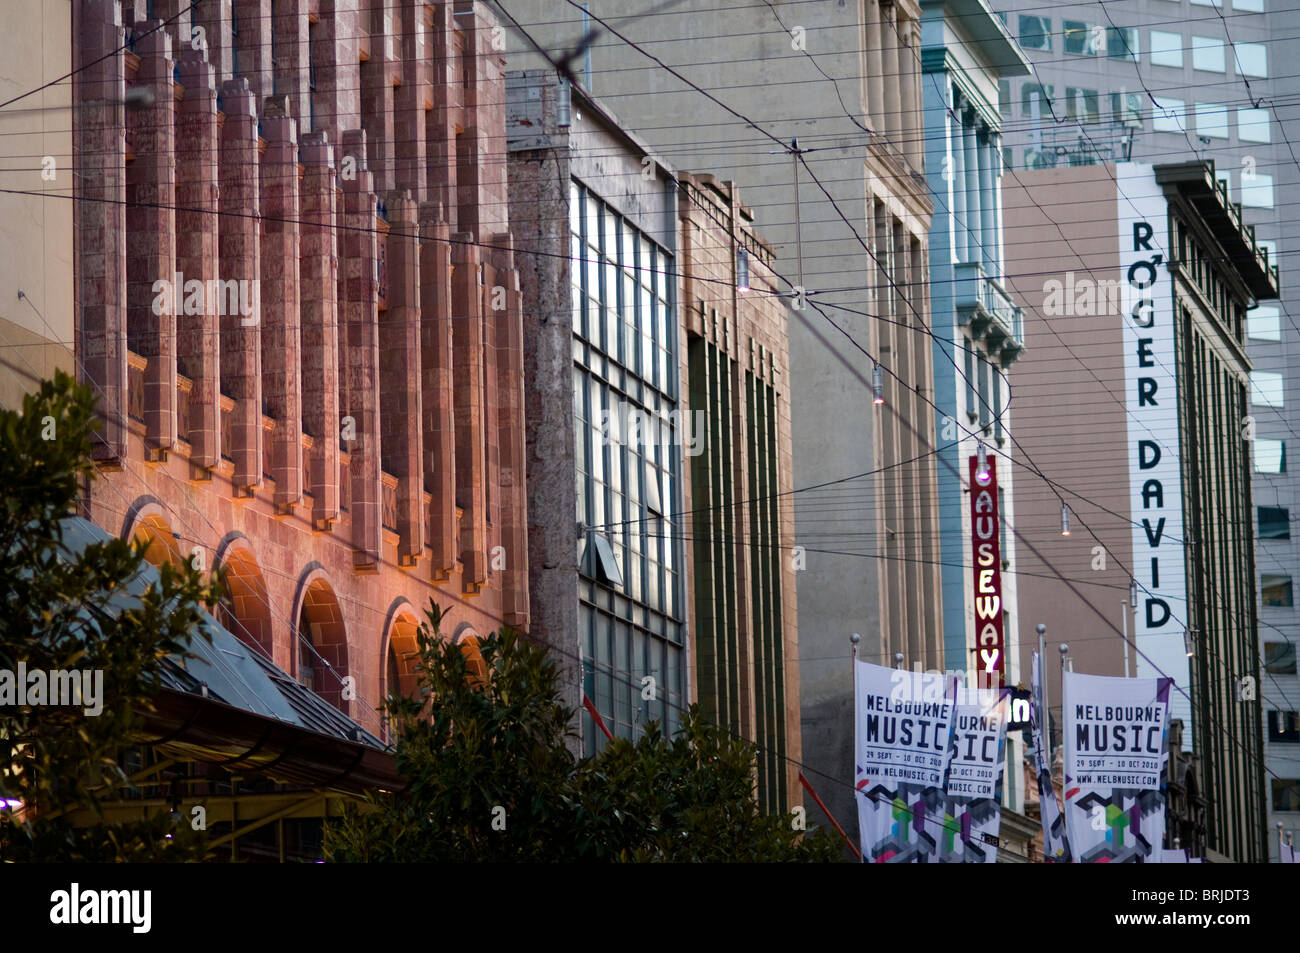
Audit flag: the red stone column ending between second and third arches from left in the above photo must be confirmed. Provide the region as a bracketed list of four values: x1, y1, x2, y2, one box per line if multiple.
[260, 104, 303, 514]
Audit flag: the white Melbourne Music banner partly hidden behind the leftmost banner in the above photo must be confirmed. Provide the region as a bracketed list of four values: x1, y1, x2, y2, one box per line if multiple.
[937, 683, 1008, 863]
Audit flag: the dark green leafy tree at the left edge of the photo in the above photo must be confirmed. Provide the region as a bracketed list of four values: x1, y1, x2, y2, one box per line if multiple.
[0, 372, 217, 861]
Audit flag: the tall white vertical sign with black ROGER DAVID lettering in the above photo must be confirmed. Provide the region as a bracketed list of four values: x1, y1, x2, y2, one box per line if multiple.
[1115, 163, 1192, 745]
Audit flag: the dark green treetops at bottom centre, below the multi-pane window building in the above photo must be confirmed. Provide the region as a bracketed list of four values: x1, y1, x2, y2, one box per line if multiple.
[325, 603, 840, 862]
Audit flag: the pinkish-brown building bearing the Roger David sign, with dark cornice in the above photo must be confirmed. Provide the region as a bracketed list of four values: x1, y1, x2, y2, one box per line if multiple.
[1004, 161, 1278, 862]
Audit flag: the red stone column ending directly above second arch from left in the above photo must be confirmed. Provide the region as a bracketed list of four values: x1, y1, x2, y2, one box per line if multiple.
[217, 79, 263, 497]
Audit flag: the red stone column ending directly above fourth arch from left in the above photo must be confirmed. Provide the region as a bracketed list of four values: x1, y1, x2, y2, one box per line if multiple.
[380, 192, 424, 566]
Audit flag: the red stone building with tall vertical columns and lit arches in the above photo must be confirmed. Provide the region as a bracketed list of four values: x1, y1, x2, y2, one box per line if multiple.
[73, 0, 528, 733]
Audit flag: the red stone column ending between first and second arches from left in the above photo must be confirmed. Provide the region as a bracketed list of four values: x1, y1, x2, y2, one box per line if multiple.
[176, 49, 221, 471]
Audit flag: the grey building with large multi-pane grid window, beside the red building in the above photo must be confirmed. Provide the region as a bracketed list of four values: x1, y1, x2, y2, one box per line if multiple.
[504, 70, 705, 755]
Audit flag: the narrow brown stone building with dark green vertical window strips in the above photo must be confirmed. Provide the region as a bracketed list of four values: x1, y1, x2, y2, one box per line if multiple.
[677, 173, 801, 811]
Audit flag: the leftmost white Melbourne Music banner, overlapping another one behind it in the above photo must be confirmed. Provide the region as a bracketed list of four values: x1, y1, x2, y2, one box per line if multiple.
[854, 662, 953, 863]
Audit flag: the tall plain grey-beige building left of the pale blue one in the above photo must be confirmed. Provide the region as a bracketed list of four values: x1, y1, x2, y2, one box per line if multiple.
[507, 0, 943, 823]
